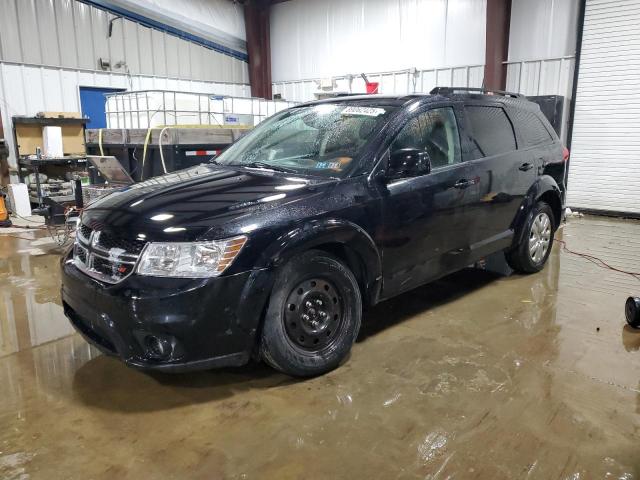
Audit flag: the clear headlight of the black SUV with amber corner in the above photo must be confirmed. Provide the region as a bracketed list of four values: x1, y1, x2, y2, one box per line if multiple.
[137, 236, 247, 278]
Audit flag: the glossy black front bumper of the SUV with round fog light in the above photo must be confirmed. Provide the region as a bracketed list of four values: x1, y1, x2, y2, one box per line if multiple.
[61, 249, 270, 371]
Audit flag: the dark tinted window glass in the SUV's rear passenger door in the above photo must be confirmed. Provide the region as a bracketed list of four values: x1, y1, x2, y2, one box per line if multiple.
[465, 105, 516, 157]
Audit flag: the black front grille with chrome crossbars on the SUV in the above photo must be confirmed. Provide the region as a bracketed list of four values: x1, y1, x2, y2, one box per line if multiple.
[73, 224, 146, 283]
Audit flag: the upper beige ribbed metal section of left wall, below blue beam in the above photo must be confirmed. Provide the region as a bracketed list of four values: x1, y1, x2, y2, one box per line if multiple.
[0, 0, 249, 83]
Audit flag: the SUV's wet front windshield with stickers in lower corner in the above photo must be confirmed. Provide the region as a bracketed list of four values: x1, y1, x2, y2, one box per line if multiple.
[215, 103, 395, 177]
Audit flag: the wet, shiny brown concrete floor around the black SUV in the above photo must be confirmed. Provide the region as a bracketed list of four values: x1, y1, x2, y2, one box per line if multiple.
[0, 218, 640, 480]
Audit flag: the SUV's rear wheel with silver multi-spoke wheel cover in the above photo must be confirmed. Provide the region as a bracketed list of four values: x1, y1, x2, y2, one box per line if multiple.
[505, 202, 556, 273]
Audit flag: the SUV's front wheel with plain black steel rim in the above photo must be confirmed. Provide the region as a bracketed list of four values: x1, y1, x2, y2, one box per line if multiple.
[260, 250, 362, 377]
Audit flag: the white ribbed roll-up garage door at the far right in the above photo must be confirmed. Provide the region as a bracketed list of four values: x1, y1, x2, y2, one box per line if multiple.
[567, 0, 640, 214]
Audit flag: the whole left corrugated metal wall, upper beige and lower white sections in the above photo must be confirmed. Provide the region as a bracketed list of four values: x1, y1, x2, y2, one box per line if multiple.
[0, 0, 250, 174]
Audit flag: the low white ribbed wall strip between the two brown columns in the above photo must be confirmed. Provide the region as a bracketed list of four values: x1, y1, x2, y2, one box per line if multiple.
[273, 65, 484, 102]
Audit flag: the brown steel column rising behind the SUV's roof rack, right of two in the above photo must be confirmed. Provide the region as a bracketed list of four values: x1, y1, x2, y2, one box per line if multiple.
[483, 0, 511, 90]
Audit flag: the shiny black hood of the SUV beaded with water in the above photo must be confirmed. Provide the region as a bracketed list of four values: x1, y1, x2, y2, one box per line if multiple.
[82, 165, 337, 241]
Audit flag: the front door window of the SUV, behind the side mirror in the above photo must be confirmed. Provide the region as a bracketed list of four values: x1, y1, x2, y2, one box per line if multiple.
[391, 107, 461, 168]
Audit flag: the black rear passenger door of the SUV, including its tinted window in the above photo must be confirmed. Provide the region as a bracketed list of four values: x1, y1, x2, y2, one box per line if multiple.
[464, 102, 537, 258]
